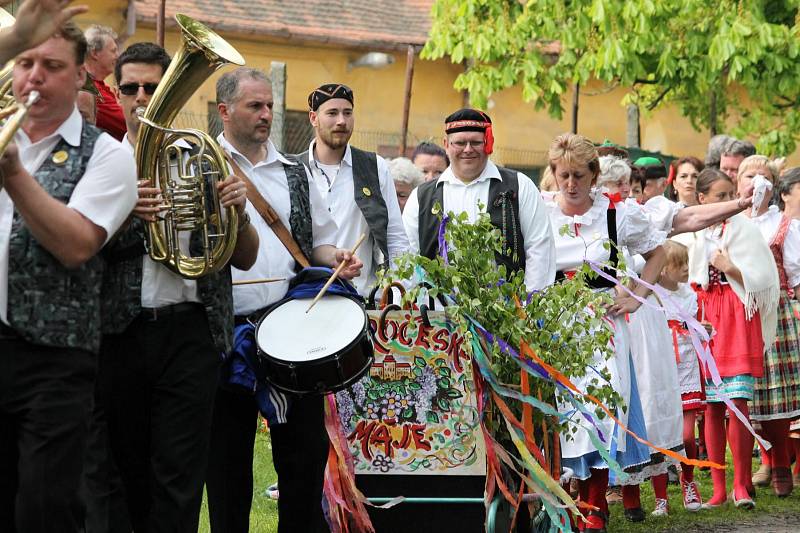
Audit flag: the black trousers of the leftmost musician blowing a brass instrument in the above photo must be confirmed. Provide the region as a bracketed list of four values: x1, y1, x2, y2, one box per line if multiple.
[0, 339, 96, 533]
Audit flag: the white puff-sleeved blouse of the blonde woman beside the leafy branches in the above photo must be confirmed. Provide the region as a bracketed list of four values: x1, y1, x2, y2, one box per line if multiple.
[542, 191, 667, 271]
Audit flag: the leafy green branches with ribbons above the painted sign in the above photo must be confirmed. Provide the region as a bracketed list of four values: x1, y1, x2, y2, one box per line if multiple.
[384, 208, 621, 440]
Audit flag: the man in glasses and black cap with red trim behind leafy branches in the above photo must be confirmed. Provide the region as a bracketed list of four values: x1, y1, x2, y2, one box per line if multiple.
[403, 109, 556, 290]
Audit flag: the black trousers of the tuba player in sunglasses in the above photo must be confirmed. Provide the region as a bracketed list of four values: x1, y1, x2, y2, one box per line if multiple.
[103, 305, 220, 533]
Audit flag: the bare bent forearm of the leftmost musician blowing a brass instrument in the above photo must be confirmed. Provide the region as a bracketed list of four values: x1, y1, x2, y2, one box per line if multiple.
[0, 144, 106, 268]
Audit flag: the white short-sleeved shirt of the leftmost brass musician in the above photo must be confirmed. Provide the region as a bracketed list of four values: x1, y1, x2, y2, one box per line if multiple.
[0, 107, 137, 323]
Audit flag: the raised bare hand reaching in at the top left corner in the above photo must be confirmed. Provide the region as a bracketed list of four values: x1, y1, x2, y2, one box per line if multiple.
[0, 0, 89, 64]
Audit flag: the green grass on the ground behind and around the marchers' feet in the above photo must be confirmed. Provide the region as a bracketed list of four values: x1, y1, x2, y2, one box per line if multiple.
[199, 426, 800, 533]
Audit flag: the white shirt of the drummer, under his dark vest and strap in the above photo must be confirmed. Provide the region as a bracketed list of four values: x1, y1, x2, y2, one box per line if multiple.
[217, 134, 337, 315]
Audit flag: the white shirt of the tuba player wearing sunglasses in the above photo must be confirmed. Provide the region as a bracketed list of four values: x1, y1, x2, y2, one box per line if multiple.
[122, 135, 200, 307]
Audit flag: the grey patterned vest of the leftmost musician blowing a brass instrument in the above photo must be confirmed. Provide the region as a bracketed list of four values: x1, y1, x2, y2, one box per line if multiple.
[8, 122, 104, 352]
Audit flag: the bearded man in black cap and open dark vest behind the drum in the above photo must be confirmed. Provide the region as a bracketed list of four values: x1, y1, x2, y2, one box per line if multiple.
[299, 83, 408, 296]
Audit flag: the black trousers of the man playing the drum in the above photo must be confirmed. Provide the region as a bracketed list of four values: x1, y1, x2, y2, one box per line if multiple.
[206, 388, 329, 533]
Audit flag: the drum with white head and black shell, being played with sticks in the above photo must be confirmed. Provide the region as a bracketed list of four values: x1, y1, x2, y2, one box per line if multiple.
[256, 294, 373, 394]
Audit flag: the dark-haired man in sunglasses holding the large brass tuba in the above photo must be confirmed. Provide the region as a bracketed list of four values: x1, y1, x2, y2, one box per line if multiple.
[96, 43, 258, 532]
